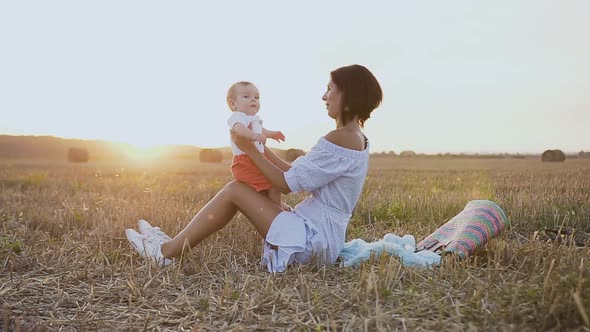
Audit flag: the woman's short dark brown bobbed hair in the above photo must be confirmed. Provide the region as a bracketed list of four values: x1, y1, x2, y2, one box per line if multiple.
[330, 65, 383, 127]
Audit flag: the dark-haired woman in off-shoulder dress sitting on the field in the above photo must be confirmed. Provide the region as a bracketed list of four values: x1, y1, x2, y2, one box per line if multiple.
[125, 65, 382, 272]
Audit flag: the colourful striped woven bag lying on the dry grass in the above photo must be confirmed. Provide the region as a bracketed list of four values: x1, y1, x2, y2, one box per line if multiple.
[416, 200, 508, 258]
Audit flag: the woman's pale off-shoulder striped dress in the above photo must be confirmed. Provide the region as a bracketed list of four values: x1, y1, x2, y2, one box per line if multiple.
[262, 137, 369, 272]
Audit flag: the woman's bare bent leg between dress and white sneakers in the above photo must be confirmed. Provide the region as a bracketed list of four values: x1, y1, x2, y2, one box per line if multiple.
[162, 181, 282, 258]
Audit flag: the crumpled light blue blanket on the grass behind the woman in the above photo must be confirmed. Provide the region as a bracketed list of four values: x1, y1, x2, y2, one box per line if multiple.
[340, 233, 440, 267]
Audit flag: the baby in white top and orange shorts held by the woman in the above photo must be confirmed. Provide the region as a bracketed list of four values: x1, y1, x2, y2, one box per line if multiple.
[227, 82, 285, 204]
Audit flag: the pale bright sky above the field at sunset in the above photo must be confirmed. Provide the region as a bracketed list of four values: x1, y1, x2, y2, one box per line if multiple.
[0, 0, 590, 153]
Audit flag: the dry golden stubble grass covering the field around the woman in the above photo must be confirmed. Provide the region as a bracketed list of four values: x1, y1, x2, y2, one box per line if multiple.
[0, 158, 590, 331]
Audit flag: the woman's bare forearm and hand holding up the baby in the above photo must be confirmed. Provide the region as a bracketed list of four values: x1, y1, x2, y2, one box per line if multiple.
[232, 132, 291, 194]
